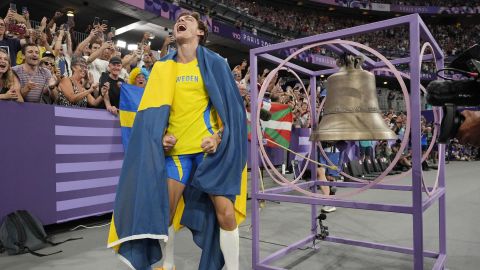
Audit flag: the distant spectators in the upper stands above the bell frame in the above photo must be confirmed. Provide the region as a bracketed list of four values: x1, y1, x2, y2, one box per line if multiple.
[223, 0, 480, 57]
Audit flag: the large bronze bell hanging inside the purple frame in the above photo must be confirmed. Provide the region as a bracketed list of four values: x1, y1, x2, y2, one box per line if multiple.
[310, 56, 397, 141]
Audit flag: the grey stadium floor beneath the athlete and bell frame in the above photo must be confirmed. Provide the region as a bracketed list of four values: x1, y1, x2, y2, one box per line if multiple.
[0, 162, 480, 270]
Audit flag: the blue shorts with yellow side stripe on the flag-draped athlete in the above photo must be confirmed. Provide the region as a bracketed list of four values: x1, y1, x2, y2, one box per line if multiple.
[165, 153, 205, 185]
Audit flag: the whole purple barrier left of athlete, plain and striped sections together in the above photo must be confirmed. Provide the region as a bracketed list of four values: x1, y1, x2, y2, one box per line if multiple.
[0, 102, 123, 224]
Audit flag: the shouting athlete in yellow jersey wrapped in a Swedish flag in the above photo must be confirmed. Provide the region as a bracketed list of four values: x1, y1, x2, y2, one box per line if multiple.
[108, 13, 247, 270]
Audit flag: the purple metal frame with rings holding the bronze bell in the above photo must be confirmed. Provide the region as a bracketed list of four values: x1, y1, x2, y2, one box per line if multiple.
[250, 14, 447, 270]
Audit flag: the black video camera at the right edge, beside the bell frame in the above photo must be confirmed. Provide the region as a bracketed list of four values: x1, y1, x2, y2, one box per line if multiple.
[427, 44, 480, 143]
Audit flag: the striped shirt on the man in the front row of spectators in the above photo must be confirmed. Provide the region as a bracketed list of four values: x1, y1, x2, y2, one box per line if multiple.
[12, 65, 52, 103]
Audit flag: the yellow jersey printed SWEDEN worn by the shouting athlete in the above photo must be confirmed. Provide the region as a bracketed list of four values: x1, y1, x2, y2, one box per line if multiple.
[166, 59, 219, 155]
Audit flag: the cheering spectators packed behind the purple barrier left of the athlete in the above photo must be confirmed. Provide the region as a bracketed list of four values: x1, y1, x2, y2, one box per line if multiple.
[0, 5, 172, 110]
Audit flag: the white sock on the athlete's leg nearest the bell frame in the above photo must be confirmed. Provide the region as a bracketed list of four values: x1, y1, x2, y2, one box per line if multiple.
[220, 227, 240, 270]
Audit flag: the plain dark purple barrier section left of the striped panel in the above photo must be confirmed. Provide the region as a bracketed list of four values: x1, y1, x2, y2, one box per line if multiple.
[0, 101, 56, 224]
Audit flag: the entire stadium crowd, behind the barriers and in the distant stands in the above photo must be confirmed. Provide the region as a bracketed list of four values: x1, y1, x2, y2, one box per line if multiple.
[0, 0, 478, 167]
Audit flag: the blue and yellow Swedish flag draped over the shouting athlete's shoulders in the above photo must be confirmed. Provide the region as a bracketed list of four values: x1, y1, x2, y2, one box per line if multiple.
[108, 46, 247, 270]
